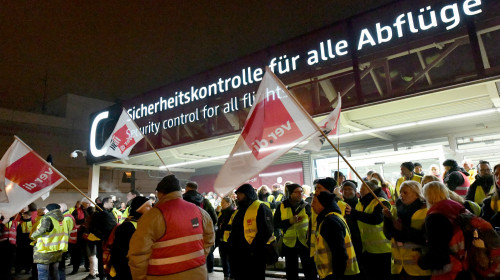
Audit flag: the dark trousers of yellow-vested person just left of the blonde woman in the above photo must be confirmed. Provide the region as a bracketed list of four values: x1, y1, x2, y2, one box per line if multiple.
[363, 252, 391, 280]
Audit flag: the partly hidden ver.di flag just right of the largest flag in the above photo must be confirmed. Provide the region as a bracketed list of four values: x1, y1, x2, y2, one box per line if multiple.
[304, 93, 342, 152]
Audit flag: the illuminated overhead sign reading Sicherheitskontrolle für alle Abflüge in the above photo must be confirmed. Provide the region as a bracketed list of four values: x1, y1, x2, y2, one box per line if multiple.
[90, 0, 487, 161]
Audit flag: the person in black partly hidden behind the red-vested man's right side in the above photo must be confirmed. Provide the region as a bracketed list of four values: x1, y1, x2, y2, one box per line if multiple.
[182, 182, 217, 273]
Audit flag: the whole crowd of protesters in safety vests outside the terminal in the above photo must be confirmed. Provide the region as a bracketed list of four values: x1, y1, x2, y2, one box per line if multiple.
[0, 160, 500, 280]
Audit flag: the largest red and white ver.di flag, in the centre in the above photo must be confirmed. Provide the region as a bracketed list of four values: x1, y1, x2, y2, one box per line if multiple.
[214, 69, 317, 193]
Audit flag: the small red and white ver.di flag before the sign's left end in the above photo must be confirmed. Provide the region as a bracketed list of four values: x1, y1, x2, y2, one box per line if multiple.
[103, 109, 143, 158]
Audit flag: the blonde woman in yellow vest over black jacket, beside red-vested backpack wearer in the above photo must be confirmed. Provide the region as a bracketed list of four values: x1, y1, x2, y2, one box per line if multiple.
[384, 181, 431, 279]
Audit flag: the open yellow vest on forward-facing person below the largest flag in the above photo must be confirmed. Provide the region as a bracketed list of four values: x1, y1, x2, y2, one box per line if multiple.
[280, 203, 309, 248]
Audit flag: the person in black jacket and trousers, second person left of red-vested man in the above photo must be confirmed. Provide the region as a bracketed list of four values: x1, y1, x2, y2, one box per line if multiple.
[89, 196, 117, 279]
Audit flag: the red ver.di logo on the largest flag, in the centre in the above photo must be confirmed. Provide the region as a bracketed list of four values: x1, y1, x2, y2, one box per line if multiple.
[241, 88, 303, 160]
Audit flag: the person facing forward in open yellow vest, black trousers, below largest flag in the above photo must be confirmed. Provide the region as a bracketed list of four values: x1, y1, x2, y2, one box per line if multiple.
[274, 183, 316, 280]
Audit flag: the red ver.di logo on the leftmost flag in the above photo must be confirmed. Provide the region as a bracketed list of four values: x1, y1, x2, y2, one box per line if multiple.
[5, 152, 61, 193]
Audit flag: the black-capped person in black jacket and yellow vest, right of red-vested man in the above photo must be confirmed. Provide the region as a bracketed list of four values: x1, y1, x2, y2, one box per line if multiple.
[228, 184, 274, 280]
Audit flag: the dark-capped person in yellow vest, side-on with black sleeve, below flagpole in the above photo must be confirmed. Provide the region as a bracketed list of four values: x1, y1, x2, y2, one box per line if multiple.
[311, 192, 360, 279]
